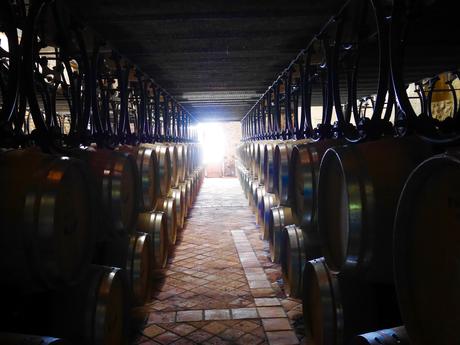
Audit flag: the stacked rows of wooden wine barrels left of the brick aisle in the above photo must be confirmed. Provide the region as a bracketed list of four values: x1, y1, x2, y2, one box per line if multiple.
[0, 143, 204, 344]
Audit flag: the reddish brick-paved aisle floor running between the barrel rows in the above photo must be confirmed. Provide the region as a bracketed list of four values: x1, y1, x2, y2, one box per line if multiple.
[136, 178, 302, 345]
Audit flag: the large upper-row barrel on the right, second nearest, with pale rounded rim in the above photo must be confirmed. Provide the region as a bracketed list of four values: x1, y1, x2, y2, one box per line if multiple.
[318, 137, 432, 283]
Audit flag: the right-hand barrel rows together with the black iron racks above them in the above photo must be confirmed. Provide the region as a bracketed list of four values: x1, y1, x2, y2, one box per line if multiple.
[238, 0, 460, 345]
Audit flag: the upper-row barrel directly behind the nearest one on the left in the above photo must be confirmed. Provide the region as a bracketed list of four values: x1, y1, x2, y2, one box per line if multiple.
[73, 147, 140, 236]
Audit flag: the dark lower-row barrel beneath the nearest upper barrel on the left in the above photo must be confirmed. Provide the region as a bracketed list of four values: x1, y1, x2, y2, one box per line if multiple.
[0, 265, 131, 345]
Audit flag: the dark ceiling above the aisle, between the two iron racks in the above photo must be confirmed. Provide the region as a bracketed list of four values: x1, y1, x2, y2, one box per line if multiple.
[72, 0, 344, 121]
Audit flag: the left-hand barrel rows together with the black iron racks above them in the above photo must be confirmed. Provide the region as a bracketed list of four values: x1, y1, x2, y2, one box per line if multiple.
[0, 0, 204, 345]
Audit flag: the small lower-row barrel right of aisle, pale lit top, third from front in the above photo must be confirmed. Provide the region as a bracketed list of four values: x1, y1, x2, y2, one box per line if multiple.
[268, 206, 295, 263]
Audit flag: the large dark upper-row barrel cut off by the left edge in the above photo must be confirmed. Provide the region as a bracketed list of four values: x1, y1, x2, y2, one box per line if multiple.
[0, 149, 96, 293]
